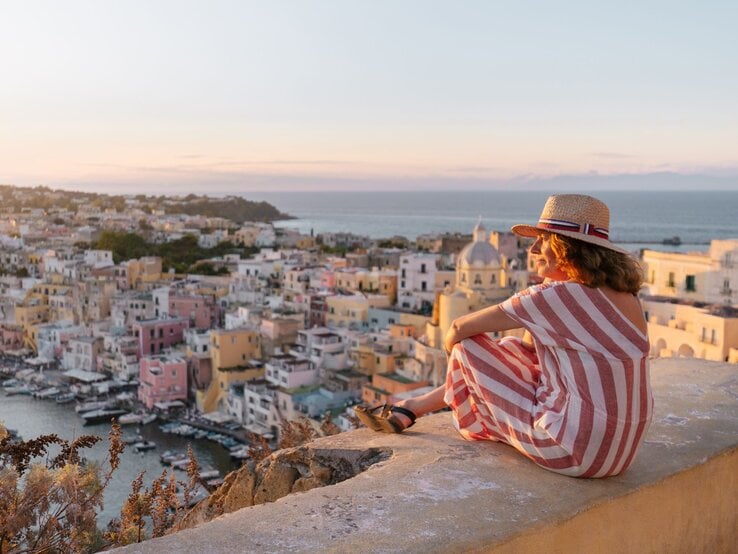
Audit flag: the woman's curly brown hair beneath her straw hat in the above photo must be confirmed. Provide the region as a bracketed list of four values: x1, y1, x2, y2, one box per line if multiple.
[550, 233, 643, 294]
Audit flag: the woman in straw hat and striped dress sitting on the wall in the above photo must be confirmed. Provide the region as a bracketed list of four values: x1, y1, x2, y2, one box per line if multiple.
[356, 194, 653, 477]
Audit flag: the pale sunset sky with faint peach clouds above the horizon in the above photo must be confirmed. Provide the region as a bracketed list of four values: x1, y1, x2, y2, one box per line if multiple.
[0, 0, 738, 194]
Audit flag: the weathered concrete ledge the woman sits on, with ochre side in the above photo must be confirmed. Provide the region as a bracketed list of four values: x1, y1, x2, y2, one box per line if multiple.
[121, 359, 738, 553]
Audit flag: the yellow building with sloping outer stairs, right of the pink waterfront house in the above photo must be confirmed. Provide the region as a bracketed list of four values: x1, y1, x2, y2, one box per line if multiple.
[197, 328, 264, 413]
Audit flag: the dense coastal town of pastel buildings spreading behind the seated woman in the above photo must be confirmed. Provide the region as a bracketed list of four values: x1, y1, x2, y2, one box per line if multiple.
[0, 187, 738, 463]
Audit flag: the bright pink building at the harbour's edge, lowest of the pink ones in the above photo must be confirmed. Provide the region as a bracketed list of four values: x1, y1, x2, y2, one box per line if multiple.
[138, 355, 187, 410]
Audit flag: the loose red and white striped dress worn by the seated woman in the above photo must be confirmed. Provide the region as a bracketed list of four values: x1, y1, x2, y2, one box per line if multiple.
[444, 282, 653, 477]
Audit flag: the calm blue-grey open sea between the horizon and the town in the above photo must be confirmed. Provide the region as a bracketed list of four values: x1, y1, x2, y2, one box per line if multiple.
[242, 190, 738, 251]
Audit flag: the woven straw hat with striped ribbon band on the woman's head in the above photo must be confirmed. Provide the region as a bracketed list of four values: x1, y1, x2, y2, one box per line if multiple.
[512, 194, 628, 254]
